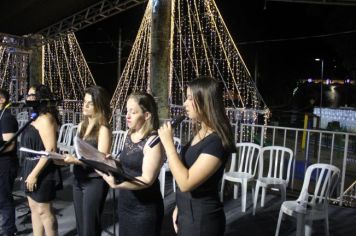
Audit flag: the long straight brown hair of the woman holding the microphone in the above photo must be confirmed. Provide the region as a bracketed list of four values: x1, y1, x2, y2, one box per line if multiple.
[188, 77, 236, 152]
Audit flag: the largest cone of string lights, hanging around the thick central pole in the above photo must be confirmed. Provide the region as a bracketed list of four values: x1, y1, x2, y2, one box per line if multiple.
[111, 0, 270, 137]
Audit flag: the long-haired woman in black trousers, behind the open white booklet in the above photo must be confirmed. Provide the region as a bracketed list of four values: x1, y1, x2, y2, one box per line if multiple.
[64, 86, 111, 236]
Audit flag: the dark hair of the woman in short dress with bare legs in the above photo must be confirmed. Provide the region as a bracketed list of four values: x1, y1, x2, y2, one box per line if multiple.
[30, 84, 59, 124]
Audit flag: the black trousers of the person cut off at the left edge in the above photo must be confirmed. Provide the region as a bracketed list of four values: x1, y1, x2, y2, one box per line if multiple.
[0, 157, 18, 235]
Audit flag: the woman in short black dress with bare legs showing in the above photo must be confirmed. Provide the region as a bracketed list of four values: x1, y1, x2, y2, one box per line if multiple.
[21, 85, 58, 236]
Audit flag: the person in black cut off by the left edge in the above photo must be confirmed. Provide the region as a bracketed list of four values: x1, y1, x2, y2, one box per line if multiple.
[0, 89, 19, 236]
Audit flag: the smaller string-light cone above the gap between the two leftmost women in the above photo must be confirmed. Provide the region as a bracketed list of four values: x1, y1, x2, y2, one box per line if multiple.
[43, 33, 95, 123]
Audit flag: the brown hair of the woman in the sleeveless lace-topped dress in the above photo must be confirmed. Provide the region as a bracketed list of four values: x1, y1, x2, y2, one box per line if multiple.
[128, 92, 159, 137]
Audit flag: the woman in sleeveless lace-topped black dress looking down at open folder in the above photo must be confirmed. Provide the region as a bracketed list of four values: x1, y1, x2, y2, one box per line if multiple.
[101, 92, 163, 236]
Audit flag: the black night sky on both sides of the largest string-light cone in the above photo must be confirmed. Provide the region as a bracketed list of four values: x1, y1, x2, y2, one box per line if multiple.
[76, 0, 356, 106]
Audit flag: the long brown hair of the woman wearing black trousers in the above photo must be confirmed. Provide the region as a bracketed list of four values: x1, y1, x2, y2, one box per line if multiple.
[79, 85, 111, 140]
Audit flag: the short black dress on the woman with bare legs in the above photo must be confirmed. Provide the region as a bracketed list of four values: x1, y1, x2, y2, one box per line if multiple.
[21, 125, 56, 202]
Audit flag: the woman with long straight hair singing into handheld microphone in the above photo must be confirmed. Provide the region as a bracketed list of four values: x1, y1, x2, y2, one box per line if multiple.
[158, 77, 236, 236]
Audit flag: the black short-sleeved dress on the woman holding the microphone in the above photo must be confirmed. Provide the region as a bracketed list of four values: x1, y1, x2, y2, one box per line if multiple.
[176, 133, 230, 236]
